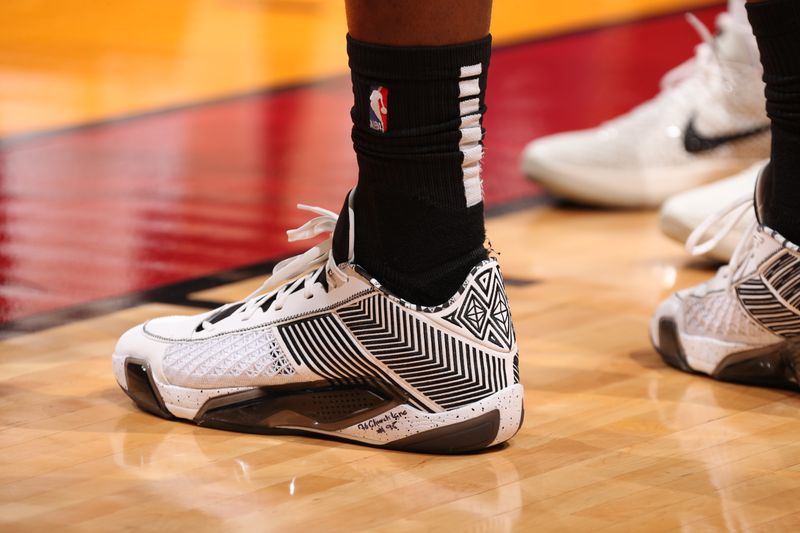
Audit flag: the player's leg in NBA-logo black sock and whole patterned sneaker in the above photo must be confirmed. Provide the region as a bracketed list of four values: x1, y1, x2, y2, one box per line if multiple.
[113, 0, 522, 452]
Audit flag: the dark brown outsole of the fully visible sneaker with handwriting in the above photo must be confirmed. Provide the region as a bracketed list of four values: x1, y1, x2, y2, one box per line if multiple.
[123, 358, 522, 455]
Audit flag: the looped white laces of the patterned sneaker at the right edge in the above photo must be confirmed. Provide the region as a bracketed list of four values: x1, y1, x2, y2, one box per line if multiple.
[686, 194, 758, 288]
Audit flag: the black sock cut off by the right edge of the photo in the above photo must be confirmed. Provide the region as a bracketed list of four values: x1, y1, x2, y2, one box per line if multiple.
[747, 0, 800, 243]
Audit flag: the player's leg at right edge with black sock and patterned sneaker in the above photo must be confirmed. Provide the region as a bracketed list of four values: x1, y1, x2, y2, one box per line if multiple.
[651, 0, 800, 389]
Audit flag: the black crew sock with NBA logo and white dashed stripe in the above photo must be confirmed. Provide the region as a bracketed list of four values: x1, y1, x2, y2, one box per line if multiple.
[344, 36, 491, 305]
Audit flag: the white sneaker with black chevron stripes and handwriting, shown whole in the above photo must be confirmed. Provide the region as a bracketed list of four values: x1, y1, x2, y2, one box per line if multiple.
[113, 193, 523, 453]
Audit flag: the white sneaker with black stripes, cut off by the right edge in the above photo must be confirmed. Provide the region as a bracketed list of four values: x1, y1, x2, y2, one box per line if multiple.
[650, 164, 800, 389]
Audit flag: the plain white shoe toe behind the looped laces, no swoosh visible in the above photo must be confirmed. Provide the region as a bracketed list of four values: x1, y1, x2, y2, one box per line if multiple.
[658, 161, 767, 263]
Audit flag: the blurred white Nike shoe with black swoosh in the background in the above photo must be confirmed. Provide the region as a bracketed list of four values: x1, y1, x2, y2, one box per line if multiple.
[522, 13, 769, 207]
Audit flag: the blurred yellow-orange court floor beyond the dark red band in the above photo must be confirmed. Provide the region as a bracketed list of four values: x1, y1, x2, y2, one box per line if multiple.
[0, 0, 719, 137]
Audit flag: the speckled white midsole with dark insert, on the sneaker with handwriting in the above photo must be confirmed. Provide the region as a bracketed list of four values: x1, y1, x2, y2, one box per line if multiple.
[115, 354, 523, 445]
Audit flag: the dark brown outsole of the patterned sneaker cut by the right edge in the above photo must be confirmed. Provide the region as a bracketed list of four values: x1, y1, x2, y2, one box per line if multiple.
[653, 318, 800, 391]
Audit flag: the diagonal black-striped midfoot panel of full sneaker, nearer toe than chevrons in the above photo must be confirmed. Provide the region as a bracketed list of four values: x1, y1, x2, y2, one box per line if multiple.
[278, 313, 432, 412]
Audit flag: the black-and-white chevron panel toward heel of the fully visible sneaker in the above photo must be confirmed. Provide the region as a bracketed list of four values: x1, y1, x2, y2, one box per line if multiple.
[337, 295, 507, 409]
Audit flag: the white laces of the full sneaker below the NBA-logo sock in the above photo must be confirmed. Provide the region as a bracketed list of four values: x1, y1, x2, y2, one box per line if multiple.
[202, 204, 349, 330]
